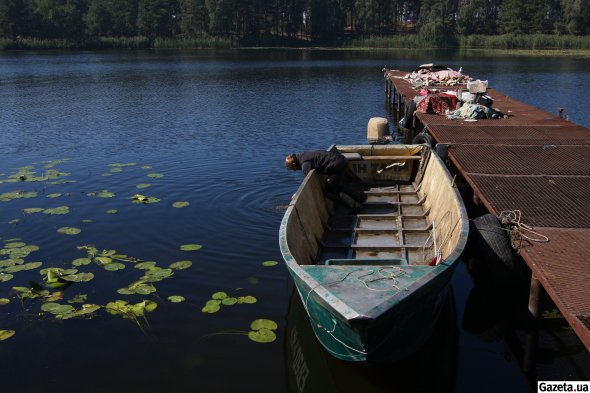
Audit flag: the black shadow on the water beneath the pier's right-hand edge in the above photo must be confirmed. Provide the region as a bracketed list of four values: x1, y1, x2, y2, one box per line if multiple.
[461, 244, 590, 391]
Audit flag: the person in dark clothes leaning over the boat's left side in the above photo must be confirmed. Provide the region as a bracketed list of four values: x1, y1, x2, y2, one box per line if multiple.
[285, 150, 367, 207]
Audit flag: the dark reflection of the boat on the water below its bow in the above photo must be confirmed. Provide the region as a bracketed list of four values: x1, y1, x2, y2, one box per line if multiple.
[283, 290, 458, 393]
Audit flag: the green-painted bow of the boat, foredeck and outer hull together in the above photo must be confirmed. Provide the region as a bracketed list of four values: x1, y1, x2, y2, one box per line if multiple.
[291, 263, 456, 362]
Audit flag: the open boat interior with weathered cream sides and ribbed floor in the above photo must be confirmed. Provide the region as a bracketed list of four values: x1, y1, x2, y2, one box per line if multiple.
[287, 145, 468, 266]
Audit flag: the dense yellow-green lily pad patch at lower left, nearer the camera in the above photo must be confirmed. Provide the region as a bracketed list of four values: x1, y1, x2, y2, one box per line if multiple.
[0, 242, 201, 340]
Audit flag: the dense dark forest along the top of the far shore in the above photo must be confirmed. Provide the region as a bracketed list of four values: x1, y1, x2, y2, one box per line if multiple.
[0, 0, 590, 46]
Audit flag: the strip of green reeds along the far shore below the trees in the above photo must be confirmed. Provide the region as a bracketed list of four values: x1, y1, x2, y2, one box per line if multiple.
[0, 34, 590, 57]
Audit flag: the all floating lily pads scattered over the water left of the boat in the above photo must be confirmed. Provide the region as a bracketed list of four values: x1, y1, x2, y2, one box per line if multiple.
[0, 159, 277, 342]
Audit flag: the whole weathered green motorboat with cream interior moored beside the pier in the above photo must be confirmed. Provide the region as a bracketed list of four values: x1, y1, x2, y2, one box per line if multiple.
[279, 144, 469, 362]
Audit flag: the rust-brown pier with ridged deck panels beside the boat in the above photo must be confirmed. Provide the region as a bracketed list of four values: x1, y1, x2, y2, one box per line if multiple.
[384, 69, 590, 360]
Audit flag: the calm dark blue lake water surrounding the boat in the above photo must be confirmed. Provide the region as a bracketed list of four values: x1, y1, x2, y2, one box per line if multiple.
[0, 50, 590, 392]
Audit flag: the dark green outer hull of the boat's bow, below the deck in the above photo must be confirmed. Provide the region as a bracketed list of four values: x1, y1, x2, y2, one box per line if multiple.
[291, 258, 456, 363]
